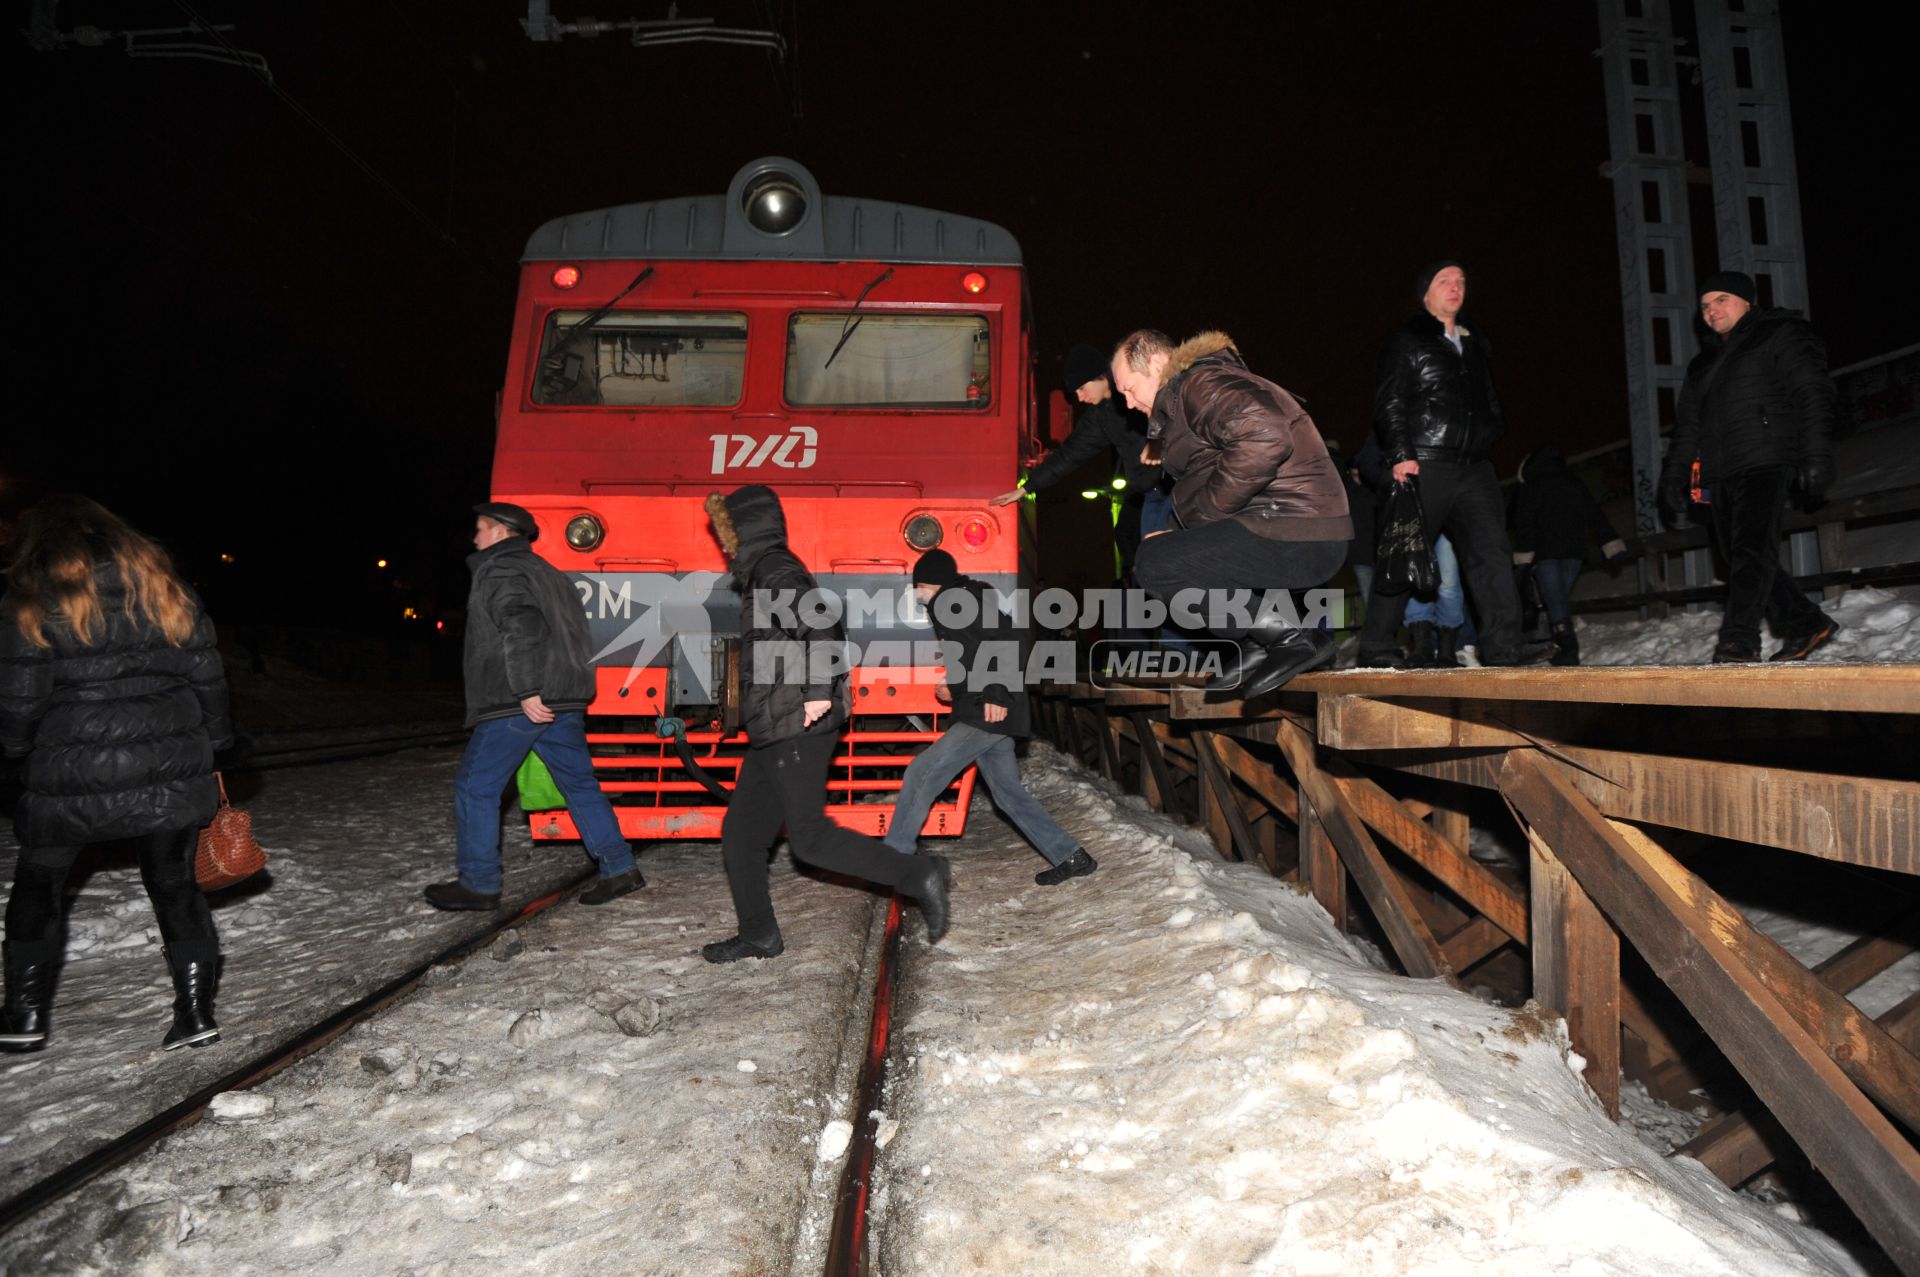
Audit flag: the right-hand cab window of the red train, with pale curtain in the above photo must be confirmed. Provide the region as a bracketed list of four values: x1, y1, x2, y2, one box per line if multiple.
[787, 311, 993, 409]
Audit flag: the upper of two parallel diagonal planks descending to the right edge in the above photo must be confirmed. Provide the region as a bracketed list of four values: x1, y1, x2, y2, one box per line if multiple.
[1611, 820, 1920, 1131]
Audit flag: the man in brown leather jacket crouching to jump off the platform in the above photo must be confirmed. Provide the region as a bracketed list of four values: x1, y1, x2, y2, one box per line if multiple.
[1112, 328, 1354, 697]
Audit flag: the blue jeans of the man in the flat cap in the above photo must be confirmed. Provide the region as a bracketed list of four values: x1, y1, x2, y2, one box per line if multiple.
[453, 711, 634, 895]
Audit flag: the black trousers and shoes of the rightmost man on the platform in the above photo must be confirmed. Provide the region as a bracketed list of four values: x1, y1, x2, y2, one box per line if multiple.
[1707, 465, 1828, 653]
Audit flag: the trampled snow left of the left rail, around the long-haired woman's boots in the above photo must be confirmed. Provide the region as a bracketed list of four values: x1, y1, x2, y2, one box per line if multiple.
[0, 751, 589, 1196]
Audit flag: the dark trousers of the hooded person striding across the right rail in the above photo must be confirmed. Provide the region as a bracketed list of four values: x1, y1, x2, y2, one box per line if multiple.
[720, 735, 929, 941]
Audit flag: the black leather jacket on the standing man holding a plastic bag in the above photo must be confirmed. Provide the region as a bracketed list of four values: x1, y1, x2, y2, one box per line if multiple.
[1373, 311, 1507, 465]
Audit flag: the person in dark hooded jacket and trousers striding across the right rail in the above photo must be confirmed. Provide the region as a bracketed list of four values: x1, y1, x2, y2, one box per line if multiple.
[701, 484, 952, 962]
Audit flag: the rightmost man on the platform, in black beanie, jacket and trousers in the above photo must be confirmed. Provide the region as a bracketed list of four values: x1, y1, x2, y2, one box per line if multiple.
[1661, 271, 1839, 663]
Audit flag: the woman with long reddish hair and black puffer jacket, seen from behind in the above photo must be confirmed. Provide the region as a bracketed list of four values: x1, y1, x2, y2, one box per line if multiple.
[0, 495, 232, 1050]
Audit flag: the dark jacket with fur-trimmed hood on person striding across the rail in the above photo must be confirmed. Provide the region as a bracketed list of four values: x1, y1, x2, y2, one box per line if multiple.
[707, 484, 852, 749]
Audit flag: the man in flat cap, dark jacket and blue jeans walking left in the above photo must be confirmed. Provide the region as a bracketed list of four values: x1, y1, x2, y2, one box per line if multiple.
[426, 501, 647, 908]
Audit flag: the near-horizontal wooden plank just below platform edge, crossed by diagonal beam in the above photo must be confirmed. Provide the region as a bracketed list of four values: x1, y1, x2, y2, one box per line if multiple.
[1367, 748, 1920, 874]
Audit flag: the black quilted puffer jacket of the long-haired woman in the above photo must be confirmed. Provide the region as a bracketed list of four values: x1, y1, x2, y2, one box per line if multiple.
[0, 561, 234, 847]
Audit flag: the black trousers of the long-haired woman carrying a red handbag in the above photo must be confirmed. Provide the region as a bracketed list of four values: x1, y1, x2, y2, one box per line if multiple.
[6, 830, 217, 962]
